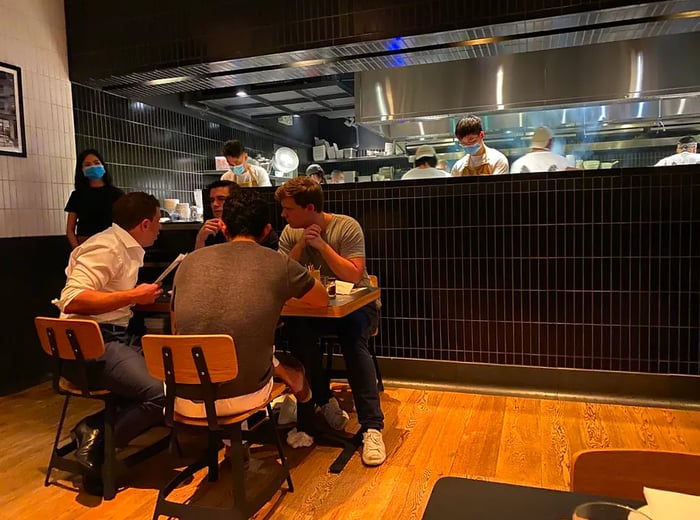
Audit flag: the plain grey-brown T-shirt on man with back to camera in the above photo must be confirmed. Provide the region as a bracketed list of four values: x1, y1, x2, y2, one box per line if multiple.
[174, 242, 314, 397]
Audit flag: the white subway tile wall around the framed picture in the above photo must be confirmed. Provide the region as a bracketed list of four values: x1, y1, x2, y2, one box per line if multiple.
[0, 0, 75, 237]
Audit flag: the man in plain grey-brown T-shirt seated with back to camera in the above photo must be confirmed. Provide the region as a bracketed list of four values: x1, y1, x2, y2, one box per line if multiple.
[174, 190, 328, 417]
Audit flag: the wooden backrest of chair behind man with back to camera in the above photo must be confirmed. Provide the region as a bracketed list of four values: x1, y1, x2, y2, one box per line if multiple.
[141, 334, 238, 385]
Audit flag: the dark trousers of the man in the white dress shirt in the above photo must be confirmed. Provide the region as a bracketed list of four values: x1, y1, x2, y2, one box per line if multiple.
[80, 326, 165, 447]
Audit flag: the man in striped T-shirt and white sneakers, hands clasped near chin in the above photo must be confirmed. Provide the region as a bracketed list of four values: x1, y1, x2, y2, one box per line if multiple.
[275, 177, 386, 466]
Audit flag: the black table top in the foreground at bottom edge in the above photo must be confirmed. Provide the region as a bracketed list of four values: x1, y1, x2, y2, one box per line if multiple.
[423, 477, 643, 520]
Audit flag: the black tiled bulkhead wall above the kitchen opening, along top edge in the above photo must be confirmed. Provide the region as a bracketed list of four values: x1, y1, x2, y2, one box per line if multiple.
[66, 0, 635, 81]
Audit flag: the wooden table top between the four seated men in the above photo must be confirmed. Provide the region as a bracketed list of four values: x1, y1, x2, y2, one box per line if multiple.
[133, 287, 381, 318]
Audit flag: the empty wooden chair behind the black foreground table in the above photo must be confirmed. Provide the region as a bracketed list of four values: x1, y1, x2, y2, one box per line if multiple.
[571, 449, 700, 500]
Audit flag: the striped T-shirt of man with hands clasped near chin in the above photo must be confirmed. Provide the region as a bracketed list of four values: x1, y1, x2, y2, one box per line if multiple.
[279, 214, 370, 287]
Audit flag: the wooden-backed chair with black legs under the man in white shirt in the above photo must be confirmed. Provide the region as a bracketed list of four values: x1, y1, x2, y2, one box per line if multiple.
[34, 317, 164, 500]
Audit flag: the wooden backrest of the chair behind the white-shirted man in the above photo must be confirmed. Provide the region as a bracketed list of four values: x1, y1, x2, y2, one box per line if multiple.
[34, 317, 105, 361]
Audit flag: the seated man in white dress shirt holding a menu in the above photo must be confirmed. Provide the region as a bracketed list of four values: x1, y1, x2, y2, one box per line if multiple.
[53, 192, 164, 494]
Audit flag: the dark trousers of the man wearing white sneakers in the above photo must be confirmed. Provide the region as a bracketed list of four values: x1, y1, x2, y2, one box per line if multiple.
[285, 304, 384, 431]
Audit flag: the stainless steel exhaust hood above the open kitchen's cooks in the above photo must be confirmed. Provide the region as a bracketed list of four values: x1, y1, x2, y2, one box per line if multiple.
[355, 32, 700, 144]
